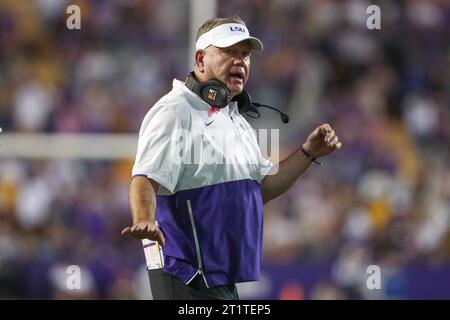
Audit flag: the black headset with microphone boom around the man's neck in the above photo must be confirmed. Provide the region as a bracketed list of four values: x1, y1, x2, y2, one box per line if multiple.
[185, 71, 289, 123]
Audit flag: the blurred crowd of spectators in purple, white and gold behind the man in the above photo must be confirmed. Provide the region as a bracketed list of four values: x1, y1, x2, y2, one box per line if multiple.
[0, 0, 450, 299]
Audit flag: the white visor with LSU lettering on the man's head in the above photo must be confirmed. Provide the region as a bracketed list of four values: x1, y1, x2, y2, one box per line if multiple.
[195, 23, 263, 51]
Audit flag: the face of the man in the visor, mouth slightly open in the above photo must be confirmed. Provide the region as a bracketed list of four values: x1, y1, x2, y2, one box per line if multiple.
[204, 41, 252, 96]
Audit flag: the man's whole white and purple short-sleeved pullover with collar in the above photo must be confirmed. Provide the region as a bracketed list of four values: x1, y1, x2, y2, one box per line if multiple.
[132, 80, 272, 287]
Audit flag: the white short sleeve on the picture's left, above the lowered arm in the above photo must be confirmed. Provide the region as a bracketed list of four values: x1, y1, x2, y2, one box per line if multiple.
[132, 106, 184, 193]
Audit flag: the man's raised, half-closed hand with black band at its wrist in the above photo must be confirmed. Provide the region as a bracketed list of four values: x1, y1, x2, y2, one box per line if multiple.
[302, 123, 342, 158]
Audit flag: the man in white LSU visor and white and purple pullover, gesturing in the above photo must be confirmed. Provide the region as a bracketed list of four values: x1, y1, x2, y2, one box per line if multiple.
[122, 16, 341, 299]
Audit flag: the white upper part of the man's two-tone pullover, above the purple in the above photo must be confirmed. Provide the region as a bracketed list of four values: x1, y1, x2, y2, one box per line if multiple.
[132, 79, 273, 195]
